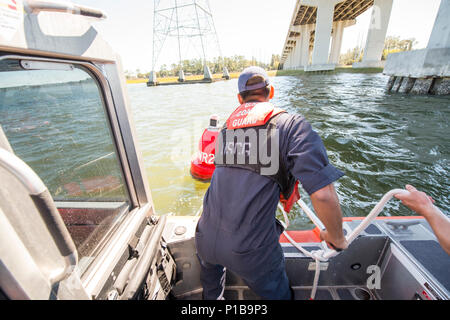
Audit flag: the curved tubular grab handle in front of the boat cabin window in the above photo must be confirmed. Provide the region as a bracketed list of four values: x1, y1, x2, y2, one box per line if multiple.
[0, 148, 78, 284]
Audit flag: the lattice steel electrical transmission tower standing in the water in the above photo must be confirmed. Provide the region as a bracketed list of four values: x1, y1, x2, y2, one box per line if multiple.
[148, 0, 229, 86]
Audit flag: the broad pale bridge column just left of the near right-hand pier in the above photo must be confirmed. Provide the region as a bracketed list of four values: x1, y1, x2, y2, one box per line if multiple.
[353, 0, 393, 68]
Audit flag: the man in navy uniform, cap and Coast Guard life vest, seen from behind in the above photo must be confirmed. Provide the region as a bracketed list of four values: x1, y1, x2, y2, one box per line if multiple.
[195, 67, 347, 300]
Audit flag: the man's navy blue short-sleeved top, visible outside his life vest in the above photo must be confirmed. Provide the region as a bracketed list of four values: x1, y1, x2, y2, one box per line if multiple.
[196, 113, 344, 273]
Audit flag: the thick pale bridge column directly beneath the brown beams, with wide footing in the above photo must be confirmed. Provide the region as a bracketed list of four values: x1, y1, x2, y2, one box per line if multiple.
[305, 0, 343, 71]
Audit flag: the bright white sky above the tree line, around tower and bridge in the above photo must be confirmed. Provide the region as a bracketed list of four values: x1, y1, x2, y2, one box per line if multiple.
[73, 0, 440, 72]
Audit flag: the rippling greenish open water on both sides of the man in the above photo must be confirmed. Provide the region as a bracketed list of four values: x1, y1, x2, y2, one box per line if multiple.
[128, 74, 450, 228]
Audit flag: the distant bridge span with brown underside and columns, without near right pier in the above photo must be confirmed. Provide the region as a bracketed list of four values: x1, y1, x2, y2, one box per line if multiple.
[281, 0, 393, 71]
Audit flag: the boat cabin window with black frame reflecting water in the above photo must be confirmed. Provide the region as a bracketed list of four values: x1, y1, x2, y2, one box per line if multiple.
[0, 60, 130, 268]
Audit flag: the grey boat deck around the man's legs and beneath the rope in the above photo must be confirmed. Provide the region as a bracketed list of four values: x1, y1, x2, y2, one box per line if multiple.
[165, 217, 450, 300]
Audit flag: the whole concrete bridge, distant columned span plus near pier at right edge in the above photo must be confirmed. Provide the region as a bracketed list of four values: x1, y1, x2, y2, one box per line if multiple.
[281, 0, 450, 95]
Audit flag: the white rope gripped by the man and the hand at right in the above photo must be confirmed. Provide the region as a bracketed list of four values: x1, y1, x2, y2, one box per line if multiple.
[278, 189, 409, 300]
